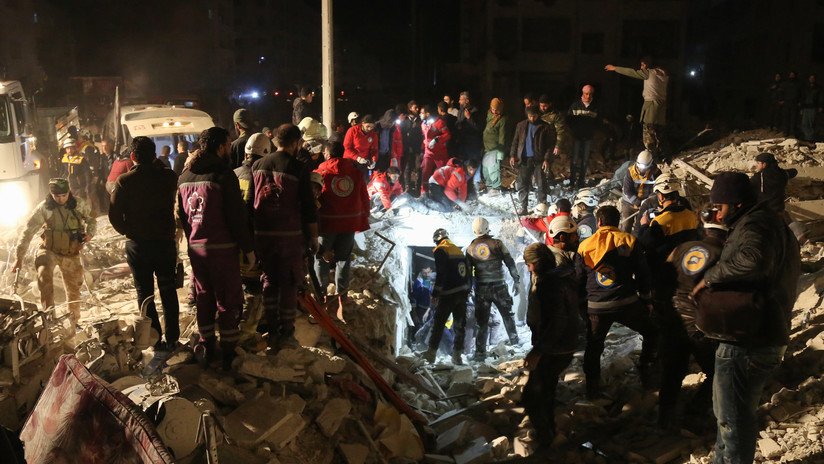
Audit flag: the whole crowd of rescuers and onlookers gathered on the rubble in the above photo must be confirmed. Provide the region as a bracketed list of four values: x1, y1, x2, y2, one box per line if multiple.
[14, 60, 800, 463]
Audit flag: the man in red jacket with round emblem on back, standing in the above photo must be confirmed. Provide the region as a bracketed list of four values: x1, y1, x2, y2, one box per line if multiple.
[315, 140, 369, 320]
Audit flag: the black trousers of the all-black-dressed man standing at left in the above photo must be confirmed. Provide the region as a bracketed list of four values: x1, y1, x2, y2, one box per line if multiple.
[126, 240, 180, 343]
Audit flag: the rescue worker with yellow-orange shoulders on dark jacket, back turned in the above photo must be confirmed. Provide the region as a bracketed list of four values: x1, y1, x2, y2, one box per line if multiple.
[578, 206, 658, 399]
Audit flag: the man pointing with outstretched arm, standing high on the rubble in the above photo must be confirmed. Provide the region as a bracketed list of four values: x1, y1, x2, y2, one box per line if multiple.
[604, 56, 669, 158]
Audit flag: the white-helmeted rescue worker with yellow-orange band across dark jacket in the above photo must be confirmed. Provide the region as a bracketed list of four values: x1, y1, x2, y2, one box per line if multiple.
[638, 174, 698, 272]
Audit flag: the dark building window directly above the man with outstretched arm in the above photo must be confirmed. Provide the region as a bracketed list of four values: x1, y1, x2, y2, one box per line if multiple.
[621, 20, 681, 59]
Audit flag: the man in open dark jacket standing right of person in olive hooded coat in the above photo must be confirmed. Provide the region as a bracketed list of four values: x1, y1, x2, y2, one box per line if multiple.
[509, 106, 555, 216]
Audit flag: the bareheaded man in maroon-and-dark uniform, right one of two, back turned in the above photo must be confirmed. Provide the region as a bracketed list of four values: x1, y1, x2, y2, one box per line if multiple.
[249, 124, 318, 350]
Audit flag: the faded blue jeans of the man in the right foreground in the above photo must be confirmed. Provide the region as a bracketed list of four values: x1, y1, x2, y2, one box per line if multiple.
[712, 343, 787, 464]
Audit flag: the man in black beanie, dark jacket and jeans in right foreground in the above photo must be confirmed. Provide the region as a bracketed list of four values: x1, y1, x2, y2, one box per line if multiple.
[692, 172, 801, 463]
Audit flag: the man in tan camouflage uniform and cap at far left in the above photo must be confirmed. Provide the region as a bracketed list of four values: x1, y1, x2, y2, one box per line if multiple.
[12, 178, 97, 324]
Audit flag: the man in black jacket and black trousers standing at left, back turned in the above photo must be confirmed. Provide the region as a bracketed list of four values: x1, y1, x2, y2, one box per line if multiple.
[109, 136, 180, 349]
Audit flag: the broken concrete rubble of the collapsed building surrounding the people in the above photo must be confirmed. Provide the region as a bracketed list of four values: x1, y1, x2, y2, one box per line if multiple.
[0, 132, 824, 464]
